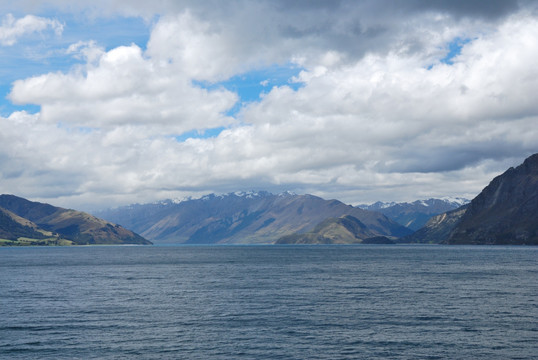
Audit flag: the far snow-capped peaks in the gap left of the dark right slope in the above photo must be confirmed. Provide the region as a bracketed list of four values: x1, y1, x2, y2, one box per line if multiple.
[357, 198, 469, 231]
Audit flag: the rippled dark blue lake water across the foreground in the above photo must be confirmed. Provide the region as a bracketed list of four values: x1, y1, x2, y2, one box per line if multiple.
[0, 245, 538, 359]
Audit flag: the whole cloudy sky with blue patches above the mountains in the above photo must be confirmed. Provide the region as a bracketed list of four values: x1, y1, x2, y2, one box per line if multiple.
[0, 0, 538, 211]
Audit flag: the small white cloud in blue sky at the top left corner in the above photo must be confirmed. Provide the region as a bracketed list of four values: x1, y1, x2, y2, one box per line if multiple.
[0, 14, 63, 46]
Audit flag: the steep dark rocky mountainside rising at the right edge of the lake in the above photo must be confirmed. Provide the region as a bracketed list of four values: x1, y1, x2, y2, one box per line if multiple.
[400, 154, 538, 245]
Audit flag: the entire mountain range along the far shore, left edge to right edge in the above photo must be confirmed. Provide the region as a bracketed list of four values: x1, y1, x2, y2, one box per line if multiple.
[0, 154, 538, 245]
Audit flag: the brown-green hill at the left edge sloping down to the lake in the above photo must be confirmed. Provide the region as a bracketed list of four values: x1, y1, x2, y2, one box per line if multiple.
[0, 195, 151, 245]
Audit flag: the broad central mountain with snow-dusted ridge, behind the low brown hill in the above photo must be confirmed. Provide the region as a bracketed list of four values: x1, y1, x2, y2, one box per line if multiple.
[95, 192, 411, 244]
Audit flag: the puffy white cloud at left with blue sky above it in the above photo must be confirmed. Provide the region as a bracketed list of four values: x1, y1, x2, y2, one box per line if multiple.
[9, 39, 237, 135]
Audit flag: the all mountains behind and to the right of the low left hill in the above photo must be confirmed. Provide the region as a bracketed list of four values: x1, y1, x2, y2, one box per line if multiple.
[96, 154, 538, 244]
